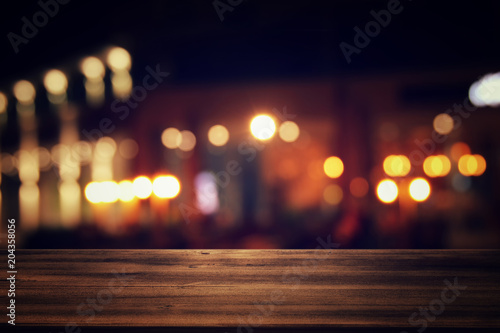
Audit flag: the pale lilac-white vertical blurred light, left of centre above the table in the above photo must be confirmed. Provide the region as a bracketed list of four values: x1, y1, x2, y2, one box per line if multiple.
[194, 171, 219, 215]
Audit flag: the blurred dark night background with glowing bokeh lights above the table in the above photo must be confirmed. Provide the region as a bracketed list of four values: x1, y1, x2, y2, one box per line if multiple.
[0, 0, 500, 249]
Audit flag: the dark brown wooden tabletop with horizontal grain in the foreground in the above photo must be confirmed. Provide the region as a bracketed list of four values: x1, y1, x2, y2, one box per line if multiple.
[0, 250, 500, 326]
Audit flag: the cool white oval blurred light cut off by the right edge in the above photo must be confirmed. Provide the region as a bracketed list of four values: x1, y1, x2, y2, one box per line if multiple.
[469, 73, 500, 106]
